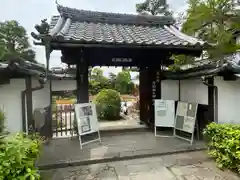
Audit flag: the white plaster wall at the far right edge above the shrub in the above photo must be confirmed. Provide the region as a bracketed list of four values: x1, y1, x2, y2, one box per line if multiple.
[214, 77, 240, 124]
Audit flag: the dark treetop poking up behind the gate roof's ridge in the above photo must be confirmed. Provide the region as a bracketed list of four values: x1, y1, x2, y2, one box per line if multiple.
[136, 0, 172, 16]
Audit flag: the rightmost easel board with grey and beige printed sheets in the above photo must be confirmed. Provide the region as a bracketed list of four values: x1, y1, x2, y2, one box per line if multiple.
[174, 102, 199, 144]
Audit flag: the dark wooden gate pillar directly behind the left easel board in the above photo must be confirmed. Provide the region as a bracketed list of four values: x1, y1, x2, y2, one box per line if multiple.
[76, 51, 89, 103]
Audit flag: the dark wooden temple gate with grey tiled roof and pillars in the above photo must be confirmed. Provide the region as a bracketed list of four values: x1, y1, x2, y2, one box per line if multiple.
[32, 5, 206, 136]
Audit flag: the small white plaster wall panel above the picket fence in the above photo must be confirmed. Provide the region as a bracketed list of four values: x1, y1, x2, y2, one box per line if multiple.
[52, 80, 77, 91]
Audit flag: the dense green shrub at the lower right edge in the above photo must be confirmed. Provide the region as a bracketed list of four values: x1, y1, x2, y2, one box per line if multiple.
[204, 123, 240, 173]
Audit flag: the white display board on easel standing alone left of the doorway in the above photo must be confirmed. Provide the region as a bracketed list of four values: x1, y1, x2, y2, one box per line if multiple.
[75, 103, 101, 149]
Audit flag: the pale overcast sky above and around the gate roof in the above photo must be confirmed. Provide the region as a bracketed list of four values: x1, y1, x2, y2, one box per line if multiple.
[0, 0, 187, 75]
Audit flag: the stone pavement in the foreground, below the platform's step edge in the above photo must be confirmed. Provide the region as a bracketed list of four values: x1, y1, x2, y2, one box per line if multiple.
[41, 151, 240, 180]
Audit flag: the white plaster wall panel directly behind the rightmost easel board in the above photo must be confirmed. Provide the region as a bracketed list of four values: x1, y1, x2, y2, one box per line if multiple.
[180, 79, 208, 105]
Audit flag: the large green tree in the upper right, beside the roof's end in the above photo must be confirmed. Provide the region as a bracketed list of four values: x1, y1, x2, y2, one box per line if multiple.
[182, 0, 240, 58]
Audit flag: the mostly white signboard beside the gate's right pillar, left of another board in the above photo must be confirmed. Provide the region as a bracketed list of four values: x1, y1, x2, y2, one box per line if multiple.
[154, 99, 175, 136]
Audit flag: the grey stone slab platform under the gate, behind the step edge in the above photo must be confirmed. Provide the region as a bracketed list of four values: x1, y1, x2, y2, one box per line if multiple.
[38, 132, 205, 167]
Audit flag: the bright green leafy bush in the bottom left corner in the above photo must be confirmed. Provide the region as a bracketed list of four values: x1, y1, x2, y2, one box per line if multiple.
[0, 133, 41, 180]
